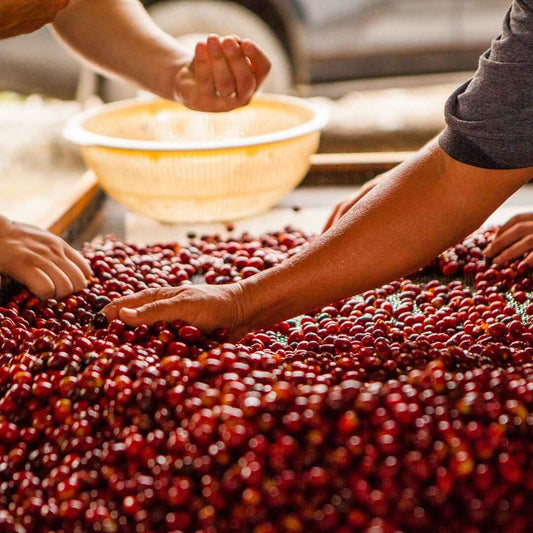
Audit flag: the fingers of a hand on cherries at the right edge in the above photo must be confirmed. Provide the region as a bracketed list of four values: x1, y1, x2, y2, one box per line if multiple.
[485, 213, 533, 267]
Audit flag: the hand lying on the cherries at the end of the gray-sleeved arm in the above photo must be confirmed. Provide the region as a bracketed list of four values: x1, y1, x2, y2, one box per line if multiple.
[103, 283, 254, 338]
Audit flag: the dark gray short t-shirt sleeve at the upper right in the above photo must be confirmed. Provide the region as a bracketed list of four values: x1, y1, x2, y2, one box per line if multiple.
[439, 0, 533, 169]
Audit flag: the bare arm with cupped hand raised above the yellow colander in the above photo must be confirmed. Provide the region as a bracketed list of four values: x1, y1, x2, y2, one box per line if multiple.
[54, 0, 270, 111]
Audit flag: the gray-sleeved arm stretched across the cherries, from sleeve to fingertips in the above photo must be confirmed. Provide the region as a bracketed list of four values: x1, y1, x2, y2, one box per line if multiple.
[107, 0, 533, 333]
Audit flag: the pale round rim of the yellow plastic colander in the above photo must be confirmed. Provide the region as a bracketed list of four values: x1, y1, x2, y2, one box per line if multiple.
[63, 94, 329, 152]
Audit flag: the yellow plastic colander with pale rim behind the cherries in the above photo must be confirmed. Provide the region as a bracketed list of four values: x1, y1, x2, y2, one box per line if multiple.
[65, 95, 326, 222]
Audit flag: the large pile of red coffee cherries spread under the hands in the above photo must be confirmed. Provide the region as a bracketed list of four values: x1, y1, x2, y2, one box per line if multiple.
[0, 228, 533, 533]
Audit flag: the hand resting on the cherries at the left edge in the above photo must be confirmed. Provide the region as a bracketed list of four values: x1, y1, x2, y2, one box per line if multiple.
[0, 217, 91, 300]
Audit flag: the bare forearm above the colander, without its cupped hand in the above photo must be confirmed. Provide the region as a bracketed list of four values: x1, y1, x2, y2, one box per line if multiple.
[54, 0, 185, 99]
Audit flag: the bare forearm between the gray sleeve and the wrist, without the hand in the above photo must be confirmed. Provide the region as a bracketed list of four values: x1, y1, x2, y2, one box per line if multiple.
[241, 142, 531, 327]
